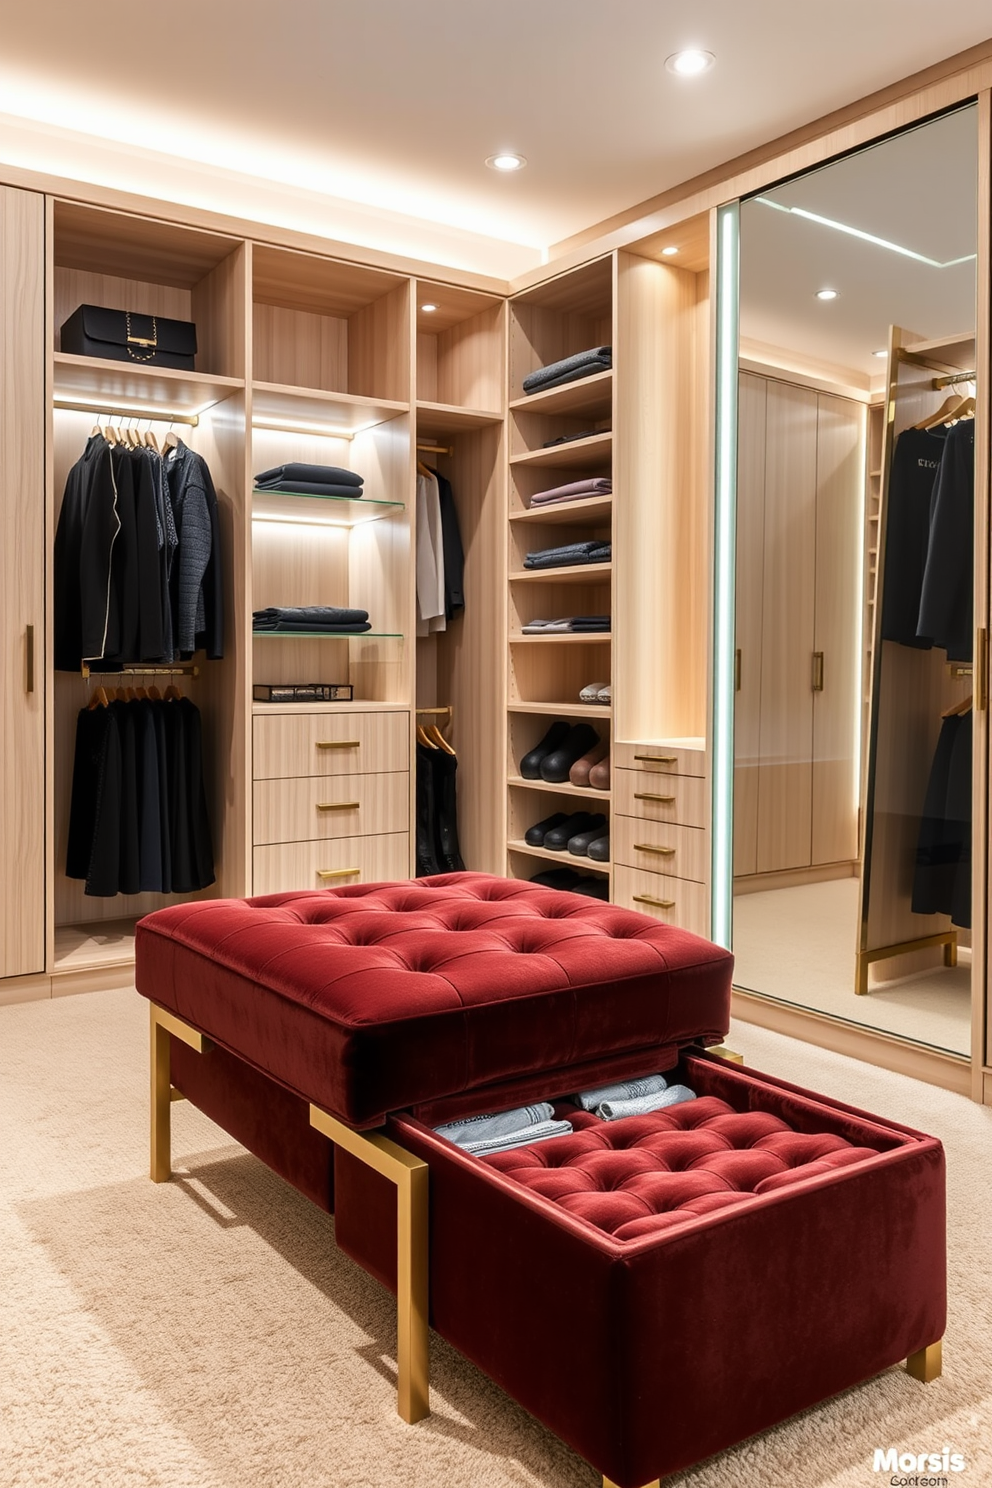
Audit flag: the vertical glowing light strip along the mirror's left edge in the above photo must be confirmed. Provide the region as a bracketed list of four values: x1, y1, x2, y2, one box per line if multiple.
[709, 201, 741, 946]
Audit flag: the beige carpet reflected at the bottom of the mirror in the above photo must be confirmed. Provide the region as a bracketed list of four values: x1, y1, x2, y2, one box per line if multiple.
[733, 878, 971, 1054]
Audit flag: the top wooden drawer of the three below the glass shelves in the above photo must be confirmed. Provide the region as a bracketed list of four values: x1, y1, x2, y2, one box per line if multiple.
[251, 713, 410, 780]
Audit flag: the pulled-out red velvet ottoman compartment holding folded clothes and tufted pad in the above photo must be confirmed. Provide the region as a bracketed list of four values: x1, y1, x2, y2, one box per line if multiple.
[335, 1054, 946, 1488]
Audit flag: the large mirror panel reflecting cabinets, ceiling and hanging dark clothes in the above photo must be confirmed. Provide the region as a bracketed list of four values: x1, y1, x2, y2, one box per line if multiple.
[733, 106, 977, 1054]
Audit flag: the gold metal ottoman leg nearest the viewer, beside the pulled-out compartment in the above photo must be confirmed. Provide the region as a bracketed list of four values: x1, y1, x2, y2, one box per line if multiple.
[309, 1106, 430, 1426]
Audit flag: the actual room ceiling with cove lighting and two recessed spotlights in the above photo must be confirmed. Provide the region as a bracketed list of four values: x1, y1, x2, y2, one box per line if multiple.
[0, 0, 992, 271]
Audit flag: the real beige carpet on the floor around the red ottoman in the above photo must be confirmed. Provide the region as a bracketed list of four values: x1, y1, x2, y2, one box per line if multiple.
[0, 991, 992, 1488]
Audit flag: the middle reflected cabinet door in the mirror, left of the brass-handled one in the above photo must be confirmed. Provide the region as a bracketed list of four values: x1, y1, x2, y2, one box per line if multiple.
[757, 381, 817, 873]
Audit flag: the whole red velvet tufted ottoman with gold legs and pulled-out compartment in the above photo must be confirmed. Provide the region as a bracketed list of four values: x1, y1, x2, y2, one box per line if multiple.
[135, 873, 944, 1488]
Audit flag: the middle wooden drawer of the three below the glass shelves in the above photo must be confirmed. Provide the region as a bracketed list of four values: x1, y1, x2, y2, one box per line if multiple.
[251, 769, 410, 845]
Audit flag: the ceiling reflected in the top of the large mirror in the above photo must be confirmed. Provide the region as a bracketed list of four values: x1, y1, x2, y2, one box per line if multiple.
[741, 106, 979, 378]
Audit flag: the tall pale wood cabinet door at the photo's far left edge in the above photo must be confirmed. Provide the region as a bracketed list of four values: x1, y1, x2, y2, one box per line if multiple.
[0, 187, 45, 976]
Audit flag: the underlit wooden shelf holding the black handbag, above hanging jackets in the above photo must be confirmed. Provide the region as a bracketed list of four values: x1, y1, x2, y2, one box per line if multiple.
[54, 351, 244, 418]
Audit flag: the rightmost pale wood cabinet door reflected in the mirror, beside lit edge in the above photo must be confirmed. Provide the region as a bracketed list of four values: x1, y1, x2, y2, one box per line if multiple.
[812, 393, 864, 863]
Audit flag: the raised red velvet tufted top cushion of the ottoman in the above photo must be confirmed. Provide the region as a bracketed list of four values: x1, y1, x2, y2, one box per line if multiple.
[135, 873, 733, 1126]
